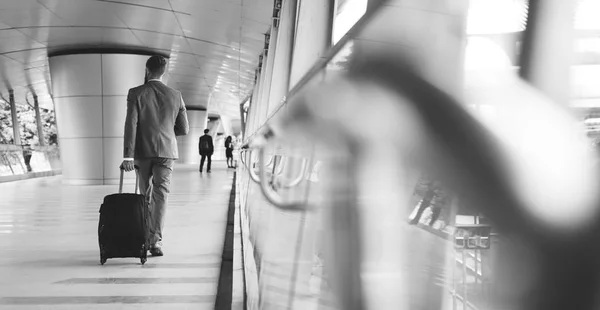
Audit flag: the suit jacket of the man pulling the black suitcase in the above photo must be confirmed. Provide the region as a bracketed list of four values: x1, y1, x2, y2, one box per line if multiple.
[123, 81, 189, 159]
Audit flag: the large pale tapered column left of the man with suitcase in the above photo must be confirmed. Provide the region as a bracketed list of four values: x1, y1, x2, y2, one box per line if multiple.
[49, 53, 148, 185]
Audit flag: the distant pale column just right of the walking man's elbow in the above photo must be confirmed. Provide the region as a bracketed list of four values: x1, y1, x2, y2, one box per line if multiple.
[177, 110, 208, 164]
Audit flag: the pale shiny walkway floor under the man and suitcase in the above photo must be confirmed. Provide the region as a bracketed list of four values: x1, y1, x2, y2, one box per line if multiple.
[0, 162, 233, 310]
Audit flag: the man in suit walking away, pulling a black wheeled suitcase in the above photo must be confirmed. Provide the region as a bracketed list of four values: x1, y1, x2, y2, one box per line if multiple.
[122, 56, 189, 256]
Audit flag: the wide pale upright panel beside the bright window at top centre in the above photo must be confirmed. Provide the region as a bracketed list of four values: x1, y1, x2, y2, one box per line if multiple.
[289, 0, 335, 89]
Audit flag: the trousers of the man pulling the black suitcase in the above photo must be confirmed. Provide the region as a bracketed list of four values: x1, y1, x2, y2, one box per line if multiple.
[135, 158, 175, 245]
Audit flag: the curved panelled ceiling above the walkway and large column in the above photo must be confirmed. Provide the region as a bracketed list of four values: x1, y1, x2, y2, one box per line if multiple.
[0, 0, 273, 118]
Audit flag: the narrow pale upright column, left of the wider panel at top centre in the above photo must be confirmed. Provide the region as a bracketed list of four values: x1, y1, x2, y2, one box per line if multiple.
[267, 0, 298, 115]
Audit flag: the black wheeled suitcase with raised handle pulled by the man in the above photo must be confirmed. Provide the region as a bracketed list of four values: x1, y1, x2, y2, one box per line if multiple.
[98, 166, 149, 265]
